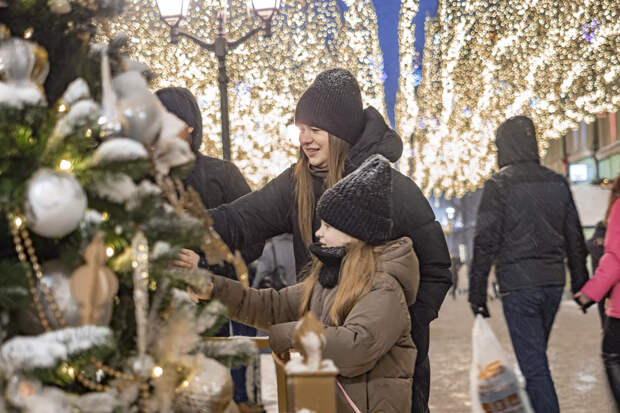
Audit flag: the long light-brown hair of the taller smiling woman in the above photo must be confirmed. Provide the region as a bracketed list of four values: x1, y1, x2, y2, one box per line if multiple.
[295, 134, 350, 248]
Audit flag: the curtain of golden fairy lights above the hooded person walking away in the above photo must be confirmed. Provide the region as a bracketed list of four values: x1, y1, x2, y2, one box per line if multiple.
[397, 0, 620, 198]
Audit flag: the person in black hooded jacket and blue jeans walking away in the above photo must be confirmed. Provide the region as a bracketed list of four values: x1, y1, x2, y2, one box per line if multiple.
[469, 116, 588, 413]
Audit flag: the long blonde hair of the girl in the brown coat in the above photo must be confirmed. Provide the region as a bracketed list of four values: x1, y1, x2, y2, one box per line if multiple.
[299, 240, 377, 326]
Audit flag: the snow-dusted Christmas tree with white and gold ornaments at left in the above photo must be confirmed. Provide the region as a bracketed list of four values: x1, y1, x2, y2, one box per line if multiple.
[0, 0, 256, 412]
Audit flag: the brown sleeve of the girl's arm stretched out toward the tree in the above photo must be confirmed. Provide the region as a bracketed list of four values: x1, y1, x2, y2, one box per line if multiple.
[212, 275, 305, 330]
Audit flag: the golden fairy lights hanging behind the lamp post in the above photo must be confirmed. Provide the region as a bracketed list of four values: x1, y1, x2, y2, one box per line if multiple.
[98, 0, 385, 186]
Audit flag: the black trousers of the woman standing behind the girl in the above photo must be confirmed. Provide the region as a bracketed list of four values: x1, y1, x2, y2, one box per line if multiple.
[409, 308, 431, 413]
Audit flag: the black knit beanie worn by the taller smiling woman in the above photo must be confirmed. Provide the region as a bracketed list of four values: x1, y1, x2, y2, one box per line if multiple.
[295, 69, 364, 145]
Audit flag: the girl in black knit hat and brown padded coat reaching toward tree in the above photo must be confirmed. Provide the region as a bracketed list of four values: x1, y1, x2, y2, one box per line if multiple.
[190, 155, 419, 412]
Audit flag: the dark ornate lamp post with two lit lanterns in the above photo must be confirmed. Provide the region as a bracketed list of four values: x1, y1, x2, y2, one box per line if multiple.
[157, 0, 280, 161]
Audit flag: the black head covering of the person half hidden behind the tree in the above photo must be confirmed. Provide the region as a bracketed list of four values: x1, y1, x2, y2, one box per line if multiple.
[155, 87, 202, 152]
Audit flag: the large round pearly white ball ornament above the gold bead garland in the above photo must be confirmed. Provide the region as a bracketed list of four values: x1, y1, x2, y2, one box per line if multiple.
[26, 169, 86, 238]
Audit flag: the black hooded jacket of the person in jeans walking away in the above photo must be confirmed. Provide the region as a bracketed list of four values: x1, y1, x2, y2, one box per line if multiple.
[469, 122, 588, 305]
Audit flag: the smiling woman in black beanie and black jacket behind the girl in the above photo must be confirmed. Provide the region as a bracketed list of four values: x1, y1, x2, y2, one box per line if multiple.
[174, 69, 452, 413]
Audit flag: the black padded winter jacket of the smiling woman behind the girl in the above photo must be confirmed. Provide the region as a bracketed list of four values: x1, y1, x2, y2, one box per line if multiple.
[209, 108, 452, 322]
